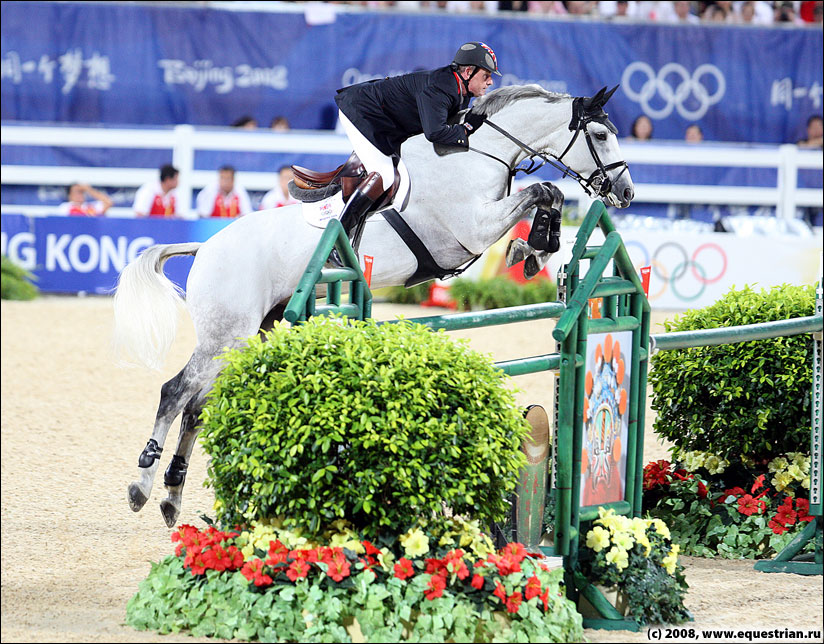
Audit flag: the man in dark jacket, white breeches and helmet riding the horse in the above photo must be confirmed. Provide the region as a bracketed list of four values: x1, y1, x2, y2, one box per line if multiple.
[335, 42, 501, 254]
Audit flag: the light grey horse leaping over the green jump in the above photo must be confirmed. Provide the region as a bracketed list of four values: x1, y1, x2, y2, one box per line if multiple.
[113, 85, 634, 527]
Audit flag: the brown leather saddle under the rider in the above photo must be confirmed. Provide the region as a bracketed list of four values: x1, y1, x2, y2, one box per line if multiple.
[289, 152, 400, 210]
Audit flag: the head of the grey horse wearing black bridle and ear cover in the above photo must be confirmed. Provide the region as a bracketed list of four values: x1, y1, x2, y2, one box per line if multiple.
[558, 85, 635, 208]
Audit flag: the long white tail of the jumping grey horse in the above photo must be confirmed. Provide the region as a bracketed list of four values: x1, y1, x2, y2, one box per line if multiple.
[113, 242, 201, 369]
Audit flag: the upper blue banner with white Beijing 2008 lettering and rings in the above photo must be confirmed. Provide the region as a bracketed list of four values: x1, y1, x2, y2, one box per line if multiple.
[0, 2, 824, 143]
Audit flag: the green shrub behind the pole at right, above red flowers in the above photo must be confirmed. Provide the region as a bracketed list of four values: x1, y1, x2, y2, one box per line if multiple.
[649, 285, 815, 463]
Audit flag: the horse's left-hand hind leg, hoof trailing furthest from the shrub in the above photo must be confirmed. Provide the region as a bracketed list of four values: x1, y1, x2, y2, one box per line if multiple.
[128, 349, 217, 512]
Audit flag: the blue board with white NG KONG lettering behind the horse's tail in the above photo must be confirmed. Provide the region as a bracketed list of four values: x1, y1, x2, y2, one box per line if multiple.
[0, 215, 233, 295]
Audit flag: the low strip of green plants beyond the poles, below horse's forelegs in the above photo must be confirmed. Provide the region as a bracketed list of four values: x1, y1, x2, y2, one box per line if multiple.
[449, 276, 558, 311]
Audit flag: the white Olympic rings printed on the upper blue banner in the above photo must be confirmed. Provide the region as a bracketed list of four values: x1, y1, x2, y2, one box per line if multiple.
[621, 60, 727, 121]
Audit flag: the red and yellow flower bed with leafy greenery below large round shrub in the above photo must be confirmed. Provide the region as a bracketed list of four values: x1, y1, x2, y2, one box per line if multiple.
[127, 519, 583, 642]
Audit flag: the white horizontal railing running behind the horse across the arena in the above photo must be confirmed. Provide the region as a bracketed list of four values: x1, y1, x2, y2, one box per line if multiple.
[0, 125, 824, 218]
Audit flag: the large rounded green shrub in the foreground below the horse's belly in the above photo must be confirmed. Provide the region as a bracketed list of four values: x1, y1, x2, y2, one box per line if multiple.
[201, 318, 528, 536]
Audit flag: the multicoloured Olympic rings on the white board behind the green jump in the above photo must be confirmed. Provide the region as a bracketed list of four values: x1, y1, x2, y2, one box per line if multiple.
[624, 240, 728, 302]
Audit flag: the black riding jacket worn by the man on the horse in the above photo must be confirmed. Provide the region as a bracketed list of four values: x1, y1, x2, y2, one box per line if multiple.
[335, 66, 471, 156]
